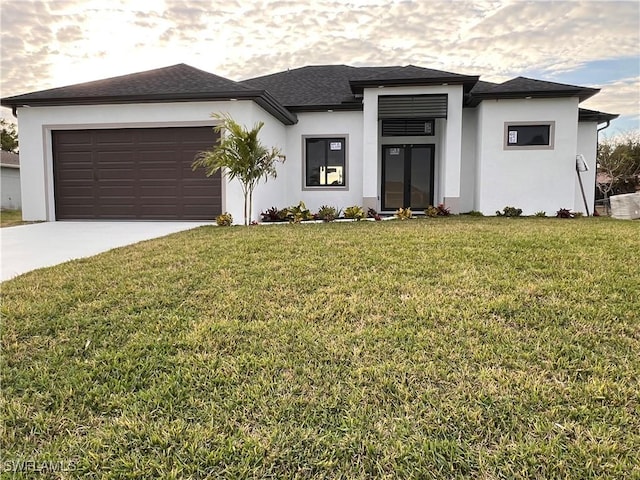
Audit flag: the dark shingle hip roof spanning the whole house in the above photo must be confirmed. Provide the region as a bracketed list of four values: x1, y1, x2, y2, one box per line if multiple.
[1, 64, 608, 125]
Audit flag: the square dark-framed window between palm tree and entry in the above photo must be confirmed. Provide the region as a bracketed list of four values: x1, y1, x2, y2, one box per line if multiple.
[304, 137, 347, 188]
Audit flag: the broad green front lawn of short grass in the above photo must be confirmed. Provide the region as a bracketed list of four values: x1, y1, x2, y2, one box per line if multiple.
[0, 217, 640, 479]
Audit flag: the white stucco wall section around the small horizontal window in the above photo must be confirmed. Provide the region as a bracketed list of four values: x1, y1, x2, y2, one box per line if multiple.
[476, 98, 578, 215]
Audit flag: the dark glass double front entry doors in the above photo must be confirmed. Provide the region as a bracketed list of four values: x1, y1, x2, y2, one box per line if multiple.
[382, 145, 434, 210]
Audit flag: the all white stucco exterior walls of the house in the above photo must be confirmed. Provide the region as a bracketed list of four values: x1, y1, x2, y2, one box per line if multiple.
[16, 92, 597, 223]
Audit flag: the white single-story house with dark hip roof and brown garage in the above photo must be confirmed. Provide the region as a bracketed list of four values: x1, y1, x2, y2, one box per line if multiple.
[1, 64, 617, 220]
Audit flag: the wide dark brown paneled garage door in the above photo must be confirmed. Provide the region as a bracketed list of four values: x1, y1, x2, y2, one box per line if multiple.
[52, 127, 221, 220]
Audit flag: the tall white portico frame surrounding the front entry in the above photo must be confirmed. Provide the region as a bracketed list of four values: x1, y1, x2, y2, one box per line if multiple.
[362, 85, 463, 213]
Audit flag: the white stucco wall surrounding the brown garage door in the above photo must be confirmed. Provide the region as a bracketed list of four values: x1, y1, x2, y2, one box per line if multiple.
[18, 101, 285, 222]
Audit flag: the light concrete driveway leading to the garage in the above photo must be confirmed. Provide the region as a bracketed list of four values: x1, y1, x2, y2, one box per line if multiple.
[0, 221, 214, 281]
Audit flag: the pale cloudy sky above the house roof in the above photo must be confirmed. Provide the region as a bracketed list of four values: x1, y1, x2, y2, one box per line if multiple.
[0, 0, 640, 134]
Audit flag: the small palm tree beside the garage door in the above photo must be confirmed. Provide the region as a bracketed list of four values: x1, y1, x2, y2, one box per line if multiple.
[192, 113, 284, 225]
